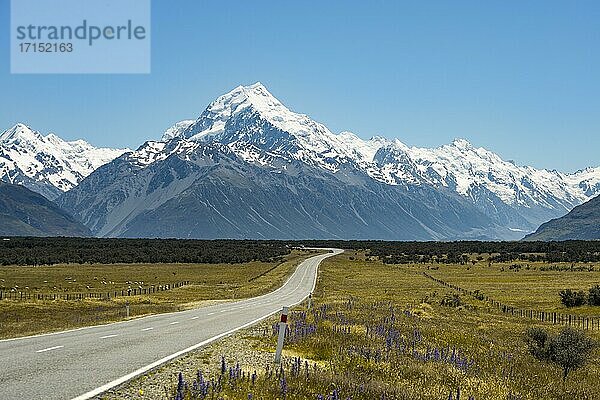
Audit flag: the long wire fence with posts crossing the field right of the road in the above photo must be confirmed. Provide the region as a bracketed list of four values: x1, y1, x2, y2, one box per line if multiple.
[423, 272, 600, 330]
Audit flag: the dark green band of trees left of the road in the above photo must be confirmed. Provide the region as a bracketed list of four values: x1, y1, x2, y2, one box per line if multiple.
[0, 237, 290, 265]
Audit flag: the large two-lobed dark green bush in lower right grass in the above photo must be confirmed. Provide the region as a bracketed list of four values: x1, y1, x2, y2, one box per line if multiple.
[526, 327, 596, 380]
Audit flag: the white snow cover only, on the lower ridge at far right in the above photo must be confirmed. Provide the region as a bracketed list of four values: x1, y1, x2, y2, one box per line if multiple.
[382, 139, 600, 212]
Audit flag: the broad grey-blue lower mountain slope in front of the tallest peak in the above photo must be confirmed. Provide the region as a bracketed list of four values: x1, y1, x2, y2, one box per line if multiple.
[57, 138, 503, 240]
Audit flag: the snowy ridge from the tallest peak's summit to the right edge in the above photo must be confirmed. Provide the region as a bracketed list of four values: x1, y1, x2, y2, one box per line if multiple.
[156, 83, 600, 231]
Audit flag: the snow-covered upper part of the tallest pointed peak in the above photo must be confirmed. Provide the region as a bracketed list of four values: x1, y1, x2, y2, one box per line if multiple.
[182, 82, 373, 172]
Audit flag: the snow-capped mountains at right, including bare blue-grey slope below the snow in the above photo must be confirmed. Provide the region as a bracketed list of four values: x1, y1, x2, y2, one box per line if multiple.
[375, 139, 600, 232]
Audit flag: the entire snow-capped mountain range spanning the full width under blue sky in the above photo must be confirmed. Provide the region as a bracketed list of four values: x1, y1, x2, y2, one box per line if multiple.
[0, 83, 600, 240]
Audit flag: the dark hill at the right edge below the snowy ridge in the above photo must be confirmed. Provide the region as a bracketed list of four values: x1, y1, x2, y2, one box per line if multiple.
[525, 196, 600, 241]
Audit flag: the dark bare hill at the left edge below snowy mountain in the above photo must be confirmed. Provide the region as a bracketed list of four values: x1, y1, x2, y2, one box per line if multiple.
[0, 181, 91, 236]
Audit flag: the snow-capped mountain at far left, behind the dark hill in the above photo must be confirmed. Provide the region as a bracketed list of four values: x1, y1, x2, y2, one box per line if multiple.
[0, 124, 130, 199]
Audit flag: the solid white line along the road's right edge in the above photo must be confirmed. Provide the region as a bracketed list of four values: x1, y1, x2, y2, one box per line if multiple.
[71, 249, 343, 400]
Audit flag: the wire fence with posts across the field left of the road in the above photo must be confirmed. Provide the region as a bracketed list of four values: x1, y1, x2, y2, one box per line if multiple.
[0, 281, 190, 300]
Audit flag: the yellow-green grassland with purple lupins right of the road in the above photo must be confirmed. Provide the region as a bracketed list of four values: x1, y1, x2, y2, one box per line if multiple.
[163, 253, 600, 400]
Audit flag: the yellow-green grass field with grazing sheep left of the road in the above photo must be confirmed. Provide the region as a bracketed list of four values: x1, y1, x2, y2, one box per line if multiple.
[0, 250, 314, 338]
